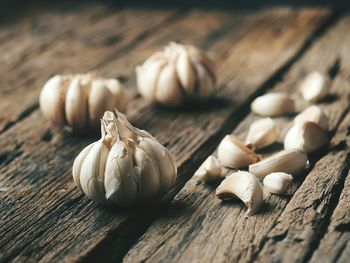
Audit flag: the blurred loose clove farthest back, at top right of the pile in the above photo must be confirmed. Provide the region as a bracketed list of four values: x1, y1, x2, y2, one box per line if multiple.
[299, 71, 330, 102]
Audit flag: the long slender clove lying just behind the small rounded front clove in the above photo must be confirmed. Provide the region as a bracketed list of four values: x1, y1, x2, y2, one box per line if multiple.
[249, 149, 308, 179]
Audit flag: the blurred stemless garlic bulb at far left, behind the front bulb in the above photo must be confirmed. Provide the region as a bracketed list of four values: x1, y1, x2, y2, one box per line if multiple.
[39, 73, 128, 132]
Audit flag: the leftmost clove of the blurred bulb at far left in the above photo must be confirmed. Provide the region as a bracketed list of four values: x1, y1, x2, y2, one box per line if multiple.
[39, 75, 66, 126]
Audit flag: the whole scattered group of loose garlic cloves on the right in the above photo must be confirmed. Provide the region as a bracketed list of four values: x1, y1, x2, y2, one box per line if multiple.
[195, 72, 329, 216]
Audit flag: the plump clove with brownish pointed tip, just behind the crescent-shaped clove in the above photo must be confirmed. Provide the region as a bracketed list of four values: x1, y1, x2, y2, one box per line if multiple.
[218, 134, 261, 168]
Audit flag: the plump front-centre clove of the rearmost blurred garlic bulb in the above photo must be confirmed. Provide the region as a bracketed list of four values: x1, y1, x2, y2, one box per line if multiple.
[156, 64, 183, 107]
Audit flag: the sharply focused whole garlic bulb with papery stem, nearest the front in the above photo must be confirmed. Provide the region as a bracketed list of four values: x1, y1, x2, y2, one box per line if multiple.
[73, 111, 177, 206]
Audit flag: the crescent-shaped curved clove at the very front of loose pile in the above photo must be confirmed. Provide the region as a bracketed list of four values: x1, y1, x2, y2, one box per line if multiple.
[215, 171, 264, 216]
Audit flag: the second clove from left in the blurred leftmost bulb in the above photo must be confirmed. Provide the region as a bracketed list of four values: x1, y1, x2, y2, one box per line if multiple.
[65, 76, 88, 130]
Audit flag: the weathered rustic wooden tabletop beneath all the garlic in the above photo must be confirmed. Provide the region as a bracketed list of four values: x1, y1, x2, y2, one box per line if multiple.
[0, 2, 350, 263]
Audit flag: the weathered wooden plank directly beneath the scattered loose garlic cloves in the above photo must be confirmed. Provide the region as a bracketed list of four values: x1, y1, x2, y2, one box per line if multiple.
[124, 14, 350, 262]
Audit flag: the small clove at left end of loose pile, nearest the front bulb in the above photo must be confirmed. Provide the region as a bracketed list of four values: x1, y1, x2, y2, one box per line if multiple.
[194, 155, 221, 182]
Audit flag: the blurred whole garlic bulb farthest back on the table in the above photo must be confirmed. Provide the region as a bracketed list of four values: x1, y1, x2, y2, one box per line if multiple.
[136, 42, 216, 107]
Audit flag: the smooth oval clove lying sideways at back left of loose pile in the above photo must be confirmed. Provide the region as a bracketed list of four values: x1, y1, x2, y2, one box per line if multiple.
[251, 92, 294, 117]
